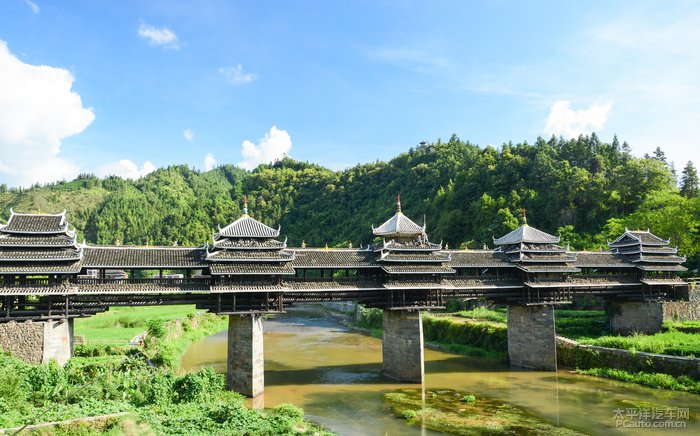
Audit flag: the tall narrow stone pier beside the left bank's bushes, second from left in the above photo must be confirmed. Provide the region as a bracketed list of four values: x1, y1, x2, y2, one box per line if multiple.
[226, 315, 265, 397]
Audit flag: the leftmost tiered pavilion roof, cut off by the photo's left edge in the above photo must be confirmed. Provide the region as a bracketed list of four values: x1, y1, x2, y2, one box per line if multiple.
[0, 209, 83, 275]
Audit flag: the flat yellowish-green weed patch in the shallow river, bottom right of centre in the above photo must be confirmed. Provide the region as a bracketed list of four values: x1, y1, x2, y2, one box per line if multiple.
[384, 389, 580, 435]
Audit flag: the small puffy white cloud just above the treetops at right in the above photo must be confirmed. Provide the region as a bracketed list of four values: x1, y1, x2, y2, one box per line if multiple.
[544, 100, 612, 138]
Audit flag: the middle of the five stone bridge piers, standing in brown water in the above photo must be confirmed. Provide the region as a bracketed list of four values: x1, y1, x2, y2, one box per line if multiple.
[382, 310, 425, 383]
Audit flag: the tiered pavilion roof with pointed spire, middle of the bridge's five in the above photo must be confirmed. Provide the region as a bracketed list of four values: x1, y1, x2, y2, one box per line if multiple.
[372, 196, 455, 274]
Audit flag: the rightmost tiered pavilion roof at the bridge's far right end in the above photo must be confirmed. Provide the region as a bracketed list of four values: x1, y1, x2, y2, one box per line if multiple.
[608, 229, 687, 272]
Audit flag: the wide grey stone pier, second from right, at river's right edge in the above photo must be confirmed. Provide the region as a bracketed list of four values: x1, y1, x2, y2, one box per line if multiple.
[508, 304, 557, 371]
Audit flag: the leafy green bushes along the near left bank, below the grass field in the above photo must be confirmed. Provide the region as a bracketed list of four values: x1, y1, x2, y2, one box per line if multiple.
[0, 355, 330, 435]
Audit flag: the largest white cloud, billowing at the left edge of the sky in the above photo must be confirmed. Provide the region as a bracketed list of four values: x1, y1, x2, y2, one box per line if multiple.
[0, 40, 95, 186]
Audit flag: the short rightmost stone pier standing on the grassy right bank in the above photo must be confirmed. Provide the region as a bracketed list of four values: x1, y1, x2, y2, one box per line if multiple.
[610, 301, 664, 335]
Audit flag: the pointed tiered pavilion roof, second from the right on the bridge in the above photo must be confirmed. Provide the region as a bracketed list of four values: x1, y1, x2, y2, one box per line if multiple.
[493, 211, 580, 273]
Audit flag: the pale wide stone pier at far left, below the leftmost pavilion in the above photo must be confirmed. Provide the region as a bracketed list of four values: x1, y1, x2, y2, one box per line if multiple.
[0, 319, 73, 365]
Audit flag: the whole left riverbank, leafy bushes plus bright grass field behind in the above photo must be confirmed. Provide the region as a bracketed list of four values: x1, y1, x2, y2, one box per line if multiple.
[0, 307, 326, 435]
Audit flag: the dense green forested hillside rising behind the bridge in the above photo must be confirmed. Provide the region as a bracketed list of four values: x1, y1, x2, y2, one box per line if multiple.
[0, 134, 700, 268]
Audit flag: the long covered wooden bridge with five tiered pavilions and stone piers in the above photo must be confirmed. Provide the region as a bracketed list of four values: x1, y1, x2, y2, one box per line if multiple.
[0, 202, 688, 396]
